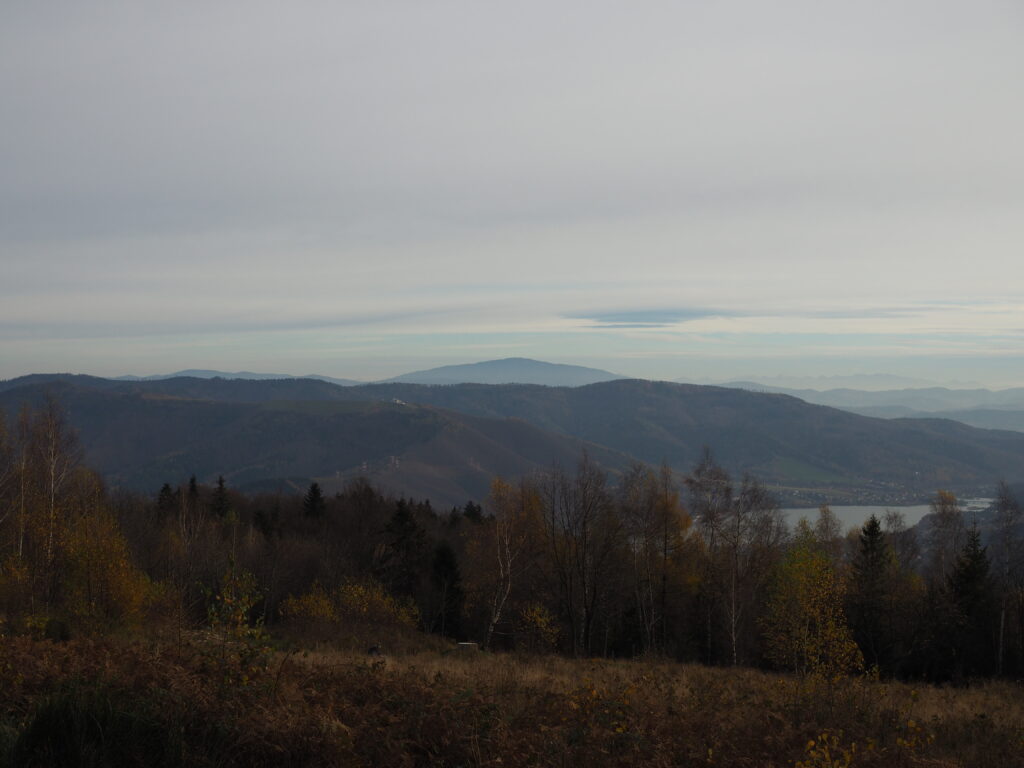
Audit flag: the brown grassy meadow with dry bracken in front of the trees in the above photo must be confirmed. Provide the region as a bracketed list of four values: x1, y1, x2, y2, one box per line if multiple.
[0, 638, 1024, 768]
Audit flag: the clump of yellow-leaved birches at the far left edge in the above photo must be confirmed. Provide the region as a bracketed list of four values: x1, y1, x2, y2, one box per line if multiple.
[0, 398, 151, 637]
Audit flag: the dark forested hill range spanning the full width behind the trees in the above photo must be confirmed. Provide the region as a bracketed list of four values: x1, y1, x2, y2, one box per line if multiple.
[0, 377, 1024, 503]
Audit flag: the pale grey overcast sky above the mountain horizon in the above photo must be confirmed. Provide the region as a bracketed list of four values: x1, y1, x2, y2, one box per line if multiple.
[0, 0, 1024, 386]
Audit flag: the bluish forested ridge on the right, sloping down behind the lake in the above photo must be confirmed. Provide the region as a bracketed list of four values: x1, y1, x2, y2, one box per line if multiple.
[321, 380, 1024, 499]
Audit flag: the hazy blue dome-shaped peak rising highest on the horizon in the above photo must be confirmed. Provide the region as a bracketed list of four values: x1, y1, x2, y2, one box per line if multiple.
[377, 357, 627, 387]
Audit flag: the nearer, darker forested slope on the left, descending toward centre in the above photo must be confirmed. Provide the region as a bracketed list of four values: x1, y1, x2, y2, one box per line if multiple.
[0, 379, 630, 506]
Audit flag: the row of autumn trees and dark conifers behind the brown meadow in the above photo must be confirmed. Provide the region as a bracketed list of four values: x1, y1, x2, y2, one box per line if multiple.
[0, 401, 1024, 680]
